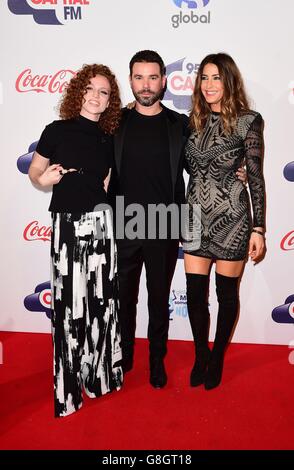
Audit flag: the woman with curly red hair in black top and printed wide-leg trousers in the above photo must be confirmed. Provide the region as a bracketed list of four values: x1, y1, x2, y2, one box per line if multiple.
[29, 64, 122, 416]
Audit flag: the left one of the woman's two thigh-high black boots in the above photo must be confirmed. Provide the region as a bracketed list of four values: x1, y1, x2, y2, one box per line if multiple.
[186, 273, 210, 387]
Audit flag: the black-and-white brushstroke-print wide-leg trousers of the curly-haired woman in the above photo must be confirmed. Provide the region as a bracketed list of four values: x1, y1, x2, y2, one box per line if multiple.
[51, 210, 123, 416]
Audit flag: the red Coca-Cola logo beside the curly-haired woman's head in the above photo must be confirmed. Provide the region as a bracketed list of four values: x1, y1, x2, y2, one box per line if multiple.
[15, 69, 75, 93]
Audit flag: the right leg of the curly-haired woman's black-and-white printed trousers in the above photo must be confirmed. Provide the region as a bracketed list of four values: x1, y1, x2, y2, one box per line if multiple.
[80, 211, 122, 398]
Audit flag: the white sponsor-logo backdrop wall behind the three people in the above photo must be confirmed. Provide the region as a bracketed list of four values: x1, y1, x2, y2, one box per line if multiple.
[0, 0, 294, 346]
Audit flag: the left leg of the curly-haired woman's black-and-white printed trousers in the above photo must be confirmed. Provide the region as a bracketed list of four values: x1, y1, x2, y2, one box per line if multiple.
[51, 214, 85, 417]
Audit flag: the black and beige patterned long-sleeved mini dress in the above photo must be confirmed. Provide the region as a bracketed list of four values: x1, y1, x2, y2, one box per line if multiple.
[184, 111, 265, 261]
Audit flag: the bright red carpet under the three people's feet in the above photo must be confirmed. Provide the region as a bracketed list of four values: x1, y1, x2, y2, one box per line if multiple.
[0, 333, 294, 450]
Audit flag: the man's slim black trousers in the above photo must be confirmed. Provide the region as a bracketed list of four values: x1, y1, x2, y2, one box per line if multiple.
[117, 240, 179, 358]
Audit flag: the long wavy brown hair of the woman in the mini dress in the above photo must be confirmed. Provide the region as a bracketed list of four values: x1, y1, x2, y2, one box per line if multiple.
[190, 52, 249, 134]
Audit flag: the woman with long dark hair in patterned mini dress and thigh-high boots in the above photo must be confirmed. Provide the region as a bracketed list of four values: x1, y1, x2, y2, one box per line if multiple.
[184, 53, 265, 390]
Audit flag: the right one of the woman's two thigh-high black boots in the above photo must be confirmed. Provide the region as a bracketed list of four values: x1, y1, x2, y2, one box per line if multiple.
[204, 273, 239, 390]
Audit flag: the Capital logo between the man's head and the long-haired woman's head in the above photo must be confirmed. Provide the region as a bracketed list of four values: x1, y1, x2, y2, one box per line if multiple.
[163, 58, 200, 111]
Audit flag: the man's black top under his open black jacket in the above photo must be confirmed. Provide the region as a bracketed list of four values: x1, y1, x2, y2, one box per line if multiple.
[121, 110, 173, 207]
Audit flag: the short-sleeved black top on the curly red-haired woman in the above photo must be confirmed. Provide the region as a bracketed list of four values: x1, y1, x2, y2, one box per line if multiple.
[36, 116, 113, 213]
